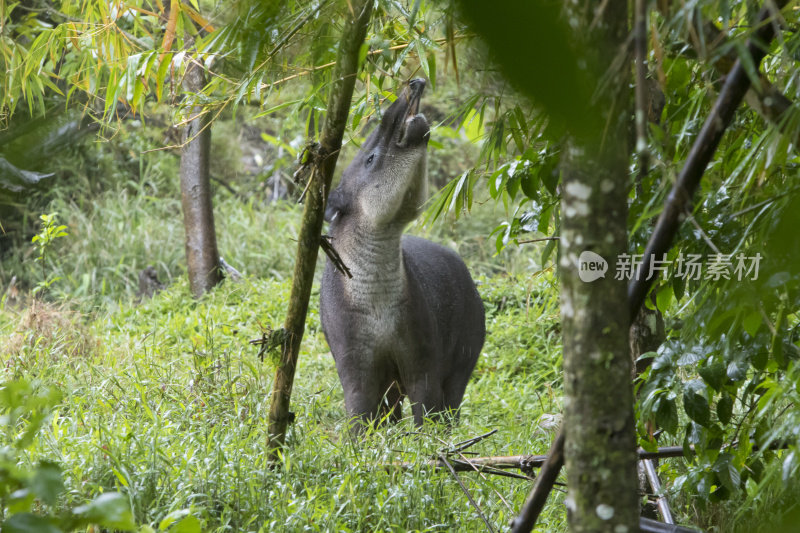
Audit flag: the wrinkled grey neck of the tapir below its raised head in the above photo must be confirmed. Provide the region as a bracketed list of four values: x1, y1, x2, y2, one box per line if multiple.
[331, 219, 405, 307]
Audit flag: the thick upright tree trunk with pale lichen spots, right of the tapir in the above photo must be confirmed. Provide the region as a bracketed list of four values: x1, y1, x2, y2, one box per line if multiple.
[560, 0, 639, 532]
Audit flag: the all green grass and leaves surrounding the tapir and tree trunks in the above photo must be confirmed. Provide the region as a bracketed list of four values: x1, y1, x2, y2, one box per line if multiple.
[0, 0, 800, 531]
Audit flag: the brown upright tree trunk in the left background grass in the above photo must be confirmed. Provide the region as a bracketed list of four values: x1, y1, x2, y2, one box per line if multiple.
[181, 63, 222, 298]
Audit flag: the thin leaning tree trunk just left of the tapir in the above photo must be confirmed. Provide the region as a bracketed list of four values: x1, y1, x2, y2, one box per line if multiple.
[269, 0, 374, 460]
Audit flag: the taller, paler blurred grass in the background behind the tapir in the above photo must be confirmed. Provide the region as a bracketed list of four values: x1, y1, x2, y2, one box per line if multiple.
[0, 108, 540, 312]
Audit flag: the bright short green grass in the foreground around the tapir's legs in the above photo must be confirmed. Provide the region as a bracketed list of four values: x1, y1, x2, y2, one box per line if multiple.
[0, 260, 564, 531]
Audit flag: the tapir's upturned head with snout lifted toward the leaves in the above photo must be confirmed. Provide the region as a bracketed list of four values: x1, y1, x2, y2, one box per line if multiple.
[325, 79, 430, 227]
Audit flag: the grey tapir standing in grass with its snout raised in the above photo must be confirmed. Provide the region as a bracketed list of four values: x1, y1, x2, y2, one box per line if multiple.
[320, 79, 486, 424]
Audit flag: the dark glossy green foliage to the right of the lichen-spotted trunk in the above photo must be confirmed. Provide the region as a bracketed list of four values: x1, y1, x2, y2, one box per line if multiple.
[631, 0, 800, 512]
